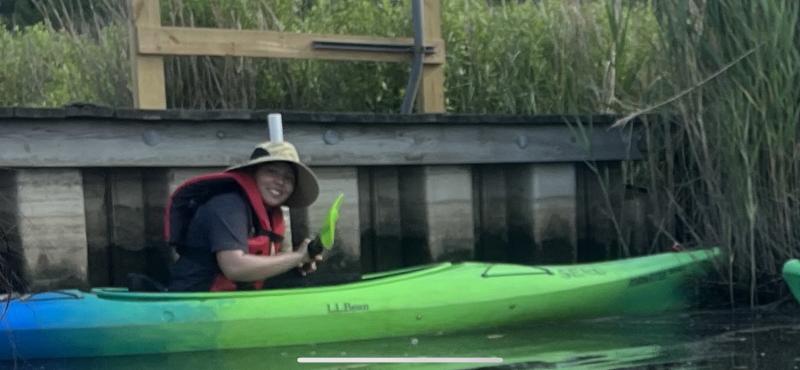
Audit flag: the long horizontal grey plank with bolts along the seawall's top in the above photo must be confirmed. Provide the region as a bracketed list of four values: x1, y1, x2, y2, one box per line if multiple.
[0, 119, 631, 167]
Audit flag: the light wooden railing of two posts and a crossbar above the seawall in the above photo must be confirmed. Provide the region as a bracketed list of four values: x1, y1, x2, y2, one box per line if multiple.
[129, 0, 445, 113]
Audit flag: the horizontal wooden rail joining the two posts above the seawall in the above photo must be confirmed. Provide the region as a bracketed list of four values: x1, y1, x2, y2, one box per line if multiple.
[137, 26, 444, 64]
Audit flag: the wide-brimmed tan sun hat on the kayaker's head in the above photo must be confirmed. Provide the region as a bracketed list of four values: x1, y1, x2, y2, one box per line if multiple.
[225, 141, 319, 207]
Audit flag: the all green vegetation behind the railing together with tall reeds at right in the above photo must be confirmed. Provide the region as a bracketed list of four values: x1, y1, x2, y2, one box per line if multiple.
[0, 0, 800, 303]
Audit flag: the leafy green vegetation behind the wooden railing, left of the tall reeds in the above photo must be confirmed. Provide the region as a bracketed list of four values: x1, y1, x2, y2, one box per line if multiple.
[0, 0, 657, 113]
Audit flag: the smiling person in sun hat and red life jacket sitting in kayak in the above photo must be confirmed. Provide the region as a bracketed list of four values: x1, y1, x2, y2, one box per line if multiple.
[165, 142, 322, 291]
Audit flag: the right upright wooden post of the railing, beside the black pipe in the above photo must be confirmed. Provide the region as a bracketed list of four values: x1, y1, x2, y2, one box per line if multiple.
[419, 0, 446, 113]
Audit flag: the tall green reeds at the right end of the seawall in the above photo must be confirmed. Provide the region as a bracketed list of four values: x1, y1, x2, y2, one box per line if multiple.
[636, 0, 800, 305]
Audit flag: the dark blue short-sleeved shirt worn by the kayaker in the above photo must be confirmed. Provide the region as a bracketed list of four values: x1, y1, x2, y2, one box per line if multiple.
[169, 192, 251, 291]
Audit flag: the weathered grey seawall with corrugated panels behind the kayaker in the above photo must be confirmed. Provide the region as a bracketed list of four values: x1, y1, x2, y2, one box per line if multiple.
[0, 107, 639, 290]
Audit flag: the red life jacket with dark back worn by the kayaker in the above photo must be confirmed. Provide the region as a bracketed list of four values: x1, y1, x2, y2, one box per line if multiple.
[164, 171, 286, 291]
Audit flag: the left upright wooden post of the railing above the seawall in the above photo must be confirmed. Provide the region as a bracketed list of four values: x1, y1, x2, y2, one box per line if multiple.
[130, 0, 167, 109]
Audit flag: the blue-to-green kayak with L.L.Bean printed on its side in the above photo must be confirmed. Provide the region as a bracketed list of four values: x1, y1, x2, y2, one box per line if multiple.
[0, 248, 719, 359]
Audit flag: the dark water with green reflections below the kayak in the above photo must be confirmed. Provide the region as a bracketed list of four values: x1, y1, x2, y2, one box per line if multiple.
[0, 306, 800, 369]
